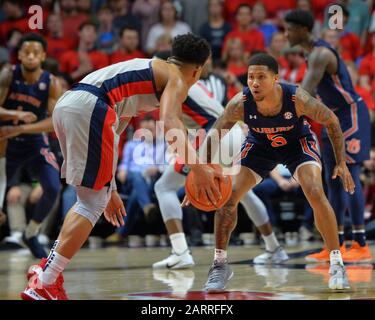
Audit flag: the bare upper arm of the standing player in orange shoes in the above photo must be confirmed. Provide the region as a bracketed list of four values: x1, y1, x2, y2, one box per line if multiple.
[301, 48, 332, 96]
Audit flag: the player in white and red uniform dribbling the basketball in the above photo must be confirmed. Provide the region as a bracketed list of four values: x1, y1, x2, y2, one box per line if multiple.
[21, 34, 223, 300]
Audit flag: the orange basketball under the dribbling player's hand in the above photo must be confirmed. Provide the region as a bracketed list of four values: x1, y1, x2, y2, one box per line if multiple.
[185, 164, 232, 211]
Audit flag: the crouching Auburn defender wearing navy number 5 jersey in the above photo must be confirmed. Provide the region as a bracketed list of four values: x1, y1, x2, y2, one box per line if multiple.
[194, 54, 354, 292]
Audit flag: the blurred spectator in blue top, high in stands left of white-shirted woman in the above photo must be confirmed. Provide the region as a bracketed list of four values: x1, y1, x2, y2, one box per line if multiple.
[97, 6, 117, 54]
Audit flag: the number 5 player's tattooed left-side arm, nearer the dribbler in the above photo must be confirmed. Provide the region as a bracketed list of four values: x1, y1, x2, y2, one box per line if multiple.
[200, 92, 244, 161]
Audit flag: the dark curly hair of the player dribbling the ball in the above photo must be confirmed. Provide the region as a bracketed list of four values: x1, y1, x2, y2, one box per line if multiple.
[172, 33, 211, 65]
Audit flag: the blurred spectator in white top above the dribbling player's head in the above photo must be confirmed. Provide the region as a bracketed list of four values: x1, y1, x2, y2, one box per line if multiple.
[146, 1, 191, 55]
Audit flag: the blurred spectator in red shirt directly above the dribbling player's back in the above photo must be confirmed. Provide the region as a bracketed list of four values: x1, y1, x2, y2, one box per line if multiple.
[110, 27, 146, 64]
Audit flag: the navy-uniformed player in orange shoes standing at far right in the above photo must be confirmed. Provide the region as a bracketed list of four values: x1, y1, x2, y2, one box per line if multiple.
[285, 10, 372, 262]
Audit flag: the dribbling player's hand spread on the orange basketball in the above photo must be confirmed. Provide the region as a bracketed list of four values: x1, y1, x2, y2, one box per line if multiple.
[191, 164, 225, 205]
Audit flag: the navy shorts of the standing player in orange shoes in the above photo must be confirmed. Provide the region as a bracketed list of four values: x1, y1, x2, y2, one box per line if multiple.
[322, 100, 371, 164]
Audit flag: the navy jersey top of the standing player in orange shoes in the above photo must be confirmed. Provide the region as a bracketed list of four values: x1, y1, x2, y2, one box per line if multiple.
[314, 39, 361, 111]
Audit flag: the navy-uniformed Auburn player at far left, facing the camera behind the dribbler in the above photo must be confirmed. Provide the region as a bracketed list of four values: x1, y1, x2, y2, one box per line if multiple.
[0, 33, 61, 259]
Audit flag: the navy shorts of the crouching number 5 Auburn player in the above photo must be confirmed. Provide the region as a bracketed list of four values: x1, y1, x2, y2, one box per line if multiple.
[241, 134, 321, 179]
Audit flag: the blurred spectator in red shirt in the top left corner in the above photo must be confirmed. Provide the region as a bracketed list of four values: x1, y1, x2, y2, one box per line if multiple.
[0, 0, 31, 44]
